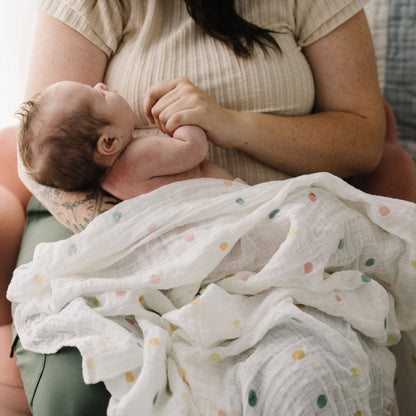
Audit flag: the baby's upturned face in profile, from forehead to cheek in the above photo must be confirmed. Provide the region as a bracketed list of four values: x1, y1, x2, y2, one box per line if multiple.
[42, 81, 135, 145]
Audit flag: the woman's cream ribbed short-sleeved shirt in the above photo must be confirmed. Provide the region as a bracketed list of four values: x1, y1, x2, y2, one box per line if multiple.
[39, 0, 366, 184]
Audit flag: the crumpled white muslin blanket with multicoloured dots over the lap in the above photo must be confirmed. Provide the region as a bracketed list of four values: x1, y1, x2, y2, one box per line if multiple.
[8, 173, 416, 416]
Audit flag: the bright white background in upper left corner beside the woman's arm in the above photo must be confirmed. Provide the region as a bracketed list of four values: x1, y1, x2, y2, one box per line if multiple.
[0, 0, 36, 128]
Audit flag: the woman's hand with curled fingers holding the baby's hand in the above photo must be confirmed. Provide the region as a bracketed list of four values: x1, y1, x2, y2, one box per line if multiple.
[143, 78, 234, 148]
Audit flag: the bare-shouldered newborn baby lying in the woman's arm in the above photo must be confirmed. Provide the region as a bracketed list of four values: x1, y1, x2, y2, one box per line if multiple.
[18, 81, 233, 199]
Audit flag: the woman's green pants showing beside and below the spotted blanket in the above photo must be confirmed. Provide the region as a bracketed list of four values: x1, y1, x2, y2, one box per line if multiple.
[13, 198, 110, 416]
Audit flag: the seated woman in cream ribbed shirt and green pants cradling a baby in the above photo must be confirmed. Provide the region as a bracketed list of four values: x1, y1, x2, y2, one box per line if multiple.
[0, 0, 410, 415]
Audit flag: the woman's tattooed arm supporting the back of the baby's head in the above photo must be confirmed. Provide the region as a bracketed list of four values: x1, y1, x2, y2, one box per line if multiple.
[20, 13, 118, 232]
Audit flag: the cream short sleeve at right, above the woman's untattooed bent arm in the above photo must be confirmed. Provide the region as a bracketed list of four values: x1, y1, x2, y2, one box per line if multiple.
[295, 0, 368, 46]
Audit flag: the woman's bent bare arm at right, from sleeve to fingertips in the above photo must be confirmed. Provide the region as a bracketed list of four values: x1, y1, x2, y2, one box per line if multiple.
[144, 12, 385, 177]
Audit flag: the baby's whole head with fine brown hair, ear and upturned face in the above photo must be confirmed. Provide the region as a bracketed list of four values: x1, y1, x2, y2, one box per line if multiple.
[18, 81, 135, 191]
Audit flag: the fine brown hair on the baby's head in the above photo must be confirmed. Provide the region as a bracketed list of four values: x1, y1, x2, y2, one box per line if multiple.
[16, 95, 110, 191]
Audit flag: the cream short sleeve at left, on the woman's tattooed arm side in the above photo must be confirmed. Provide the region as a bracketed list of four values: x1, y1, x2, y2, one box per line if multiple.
[37, 0, 130, 57]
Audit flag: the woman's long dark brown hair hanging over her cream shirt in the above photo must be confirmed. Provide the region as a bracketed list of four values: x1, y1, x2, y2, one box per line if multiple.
[184, 0, 280, 58]
